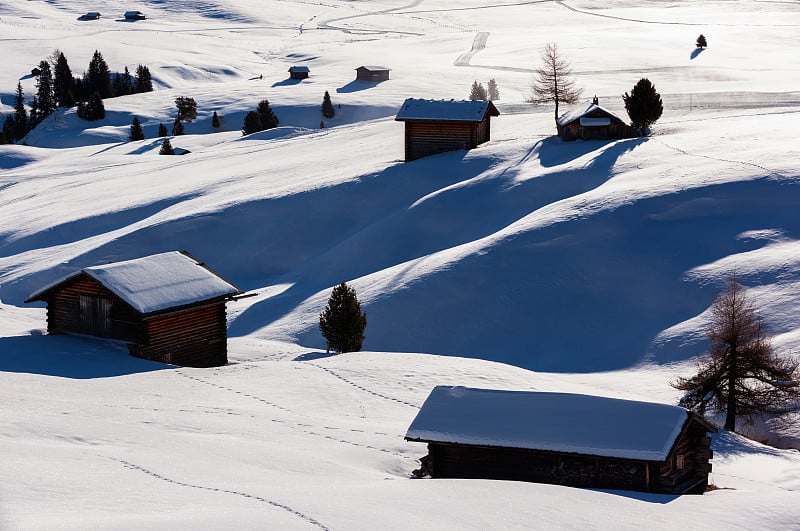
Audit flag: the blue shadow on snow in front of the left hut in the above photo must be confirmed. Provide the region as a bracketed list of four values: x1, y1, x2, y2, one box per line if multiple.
[0, 334, 169, 379]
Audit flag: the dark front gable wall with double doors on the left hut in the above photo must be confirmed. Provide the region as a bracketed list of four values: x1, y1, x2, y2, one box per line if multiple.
[47, 275, 142, 341]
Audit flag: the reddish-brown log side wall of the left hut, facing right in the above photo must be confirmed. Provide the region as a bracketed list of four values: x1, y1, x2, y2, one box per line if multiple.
[132, 302, 228, 367]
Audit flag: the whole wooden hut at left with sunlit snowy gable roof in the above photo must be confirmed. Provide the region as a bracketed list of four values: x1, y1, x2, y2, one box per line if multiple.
[25, 251, 241, 367]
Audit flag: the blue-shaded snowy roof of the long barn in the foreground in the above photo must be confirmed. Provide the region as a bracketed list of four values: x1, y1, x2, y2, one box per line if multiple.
[406, 386, 689, 461]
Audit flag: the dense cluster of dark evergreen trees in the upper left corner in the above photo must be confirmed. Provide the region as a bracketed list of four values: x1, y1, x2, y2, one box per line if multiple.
[0, 50, 153, 143]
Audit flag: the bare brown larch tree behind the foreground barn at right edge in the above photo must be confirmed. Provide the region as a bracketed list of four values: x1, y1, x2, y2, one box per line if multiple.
[672, 277, 800, 431]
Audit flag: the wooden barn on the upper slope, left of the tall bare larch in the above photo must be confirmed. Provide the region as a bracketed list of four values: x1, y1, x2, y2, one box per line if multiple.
[395, 98, 500, 161]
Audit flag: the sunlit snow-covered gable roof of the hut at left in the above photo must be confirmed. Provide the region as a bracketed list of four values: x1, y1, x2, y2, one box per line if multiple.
[28, 251, 241, 314]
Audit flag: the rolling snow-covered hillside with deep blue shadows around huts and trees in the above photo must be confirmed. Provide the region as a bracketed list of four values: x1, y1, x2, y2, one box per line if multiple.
[0, 0, 800, 530]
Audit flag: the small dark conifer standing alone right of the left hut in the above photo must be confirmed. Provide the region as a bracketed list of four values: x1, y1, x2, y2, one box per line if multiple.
[319, 282, 367, 352]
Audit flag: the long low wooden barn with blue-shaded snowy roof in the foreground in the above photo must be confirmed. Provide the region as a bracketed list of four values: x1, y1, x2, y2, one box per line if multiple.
[405, 387, 717, 494]
